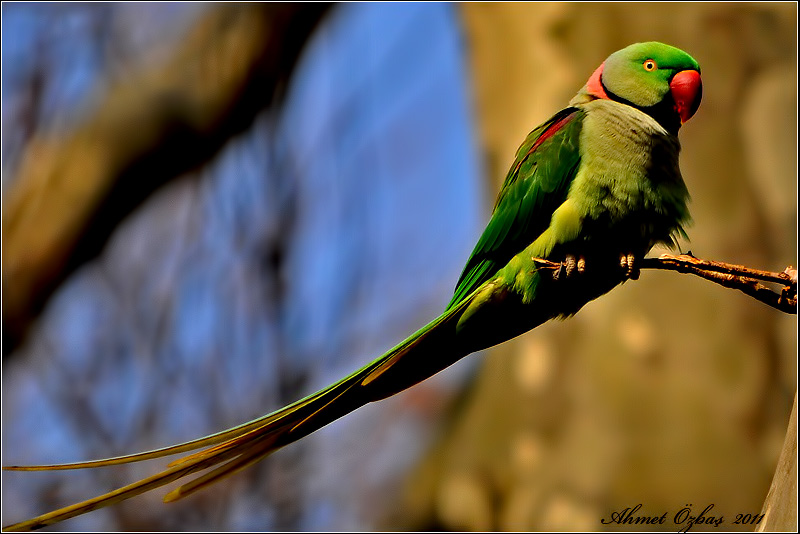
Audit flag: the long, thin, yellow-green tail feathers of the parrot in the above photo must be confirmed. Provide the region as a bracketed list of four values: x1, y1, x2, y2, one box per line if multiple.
[3, 290, 479, 531]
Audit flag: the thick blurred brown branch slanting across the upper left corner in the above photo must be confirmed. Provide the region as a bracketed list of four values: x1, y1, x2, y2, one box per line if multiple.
[2, 3, 328, 355]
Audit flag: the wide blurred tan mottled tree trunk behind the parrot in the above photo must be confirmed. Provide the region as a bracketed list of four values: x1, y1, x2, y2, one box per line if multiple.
[395, 3, 797, 531]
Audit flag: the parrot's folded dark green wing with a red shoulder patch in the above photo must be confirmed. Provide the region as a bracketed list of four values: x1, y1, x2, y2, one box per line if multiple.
[447, 108, 584, 309]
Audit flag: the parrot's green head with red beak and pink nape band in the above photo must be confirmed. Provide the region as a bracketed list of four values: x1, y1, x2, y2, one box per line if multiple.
[581, 42, 703, 132]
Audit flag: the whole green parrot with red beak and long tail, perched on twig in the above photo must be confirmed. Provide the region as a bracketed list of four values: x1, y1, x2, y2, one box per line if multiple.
[6, 42, 702, 530]
